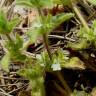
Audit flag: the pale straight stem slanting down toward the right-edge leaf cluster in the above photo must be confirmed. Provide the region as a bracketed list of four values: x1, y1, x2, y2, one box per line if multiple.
[72, 2, 90, 32]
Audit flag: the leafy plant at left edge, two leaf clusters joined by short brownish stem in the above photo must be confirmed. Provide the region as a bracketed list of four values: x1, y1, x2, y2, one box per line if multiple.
[0, 10, 26, 70]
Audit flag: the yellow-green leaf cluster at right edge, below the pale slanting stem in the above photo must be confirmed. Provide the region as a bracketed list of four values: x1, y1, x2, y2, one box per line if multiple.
[68, 20, 96, 50]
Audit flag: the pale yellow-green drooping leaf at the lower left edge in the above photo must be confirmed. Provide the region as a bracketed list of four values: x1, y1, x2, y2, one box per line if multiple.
[1, 53, 10, 72]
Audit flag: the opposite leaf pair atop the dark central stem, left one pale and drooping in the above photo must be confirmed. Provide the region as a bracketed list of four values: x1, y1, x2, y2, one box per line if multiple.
[27, 13, 74, 42]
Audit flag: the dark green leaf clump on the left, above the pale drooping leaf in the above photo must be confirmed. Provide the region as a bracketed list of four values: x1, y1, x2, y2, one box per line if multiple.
[6, 34, 26, 62]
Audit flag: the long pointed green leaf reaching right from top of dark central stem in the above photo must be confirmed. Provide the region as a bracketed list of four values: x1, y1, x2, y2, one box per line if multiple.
[41, 13, 74, 33]
